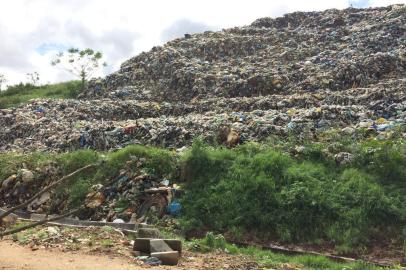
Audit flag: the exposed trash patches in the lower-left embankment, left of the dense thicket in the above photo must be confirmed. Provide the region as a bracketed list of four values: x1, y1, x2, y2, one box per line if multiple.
[0, 157, 181, 226]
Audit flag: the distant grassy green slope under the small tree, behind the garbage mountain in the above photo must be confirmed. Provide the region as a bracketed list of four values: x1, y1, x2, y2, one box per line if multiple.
[0, 81, 81, 109]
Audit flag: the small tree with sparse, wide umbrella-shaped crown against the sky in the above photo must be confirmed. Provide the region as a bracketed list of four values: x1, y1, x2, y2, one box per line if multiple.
[51, 48, 107, 87]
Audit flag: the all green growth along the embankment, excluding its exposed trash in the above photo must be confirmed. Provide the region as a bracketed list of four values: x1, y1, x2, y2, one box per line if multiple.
[0, 137, 406, 254]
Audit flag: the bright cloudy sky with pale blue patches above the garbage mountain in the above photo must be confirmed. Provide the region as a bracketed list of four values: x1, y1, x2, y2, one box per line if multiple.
[0, 0, 406, 88]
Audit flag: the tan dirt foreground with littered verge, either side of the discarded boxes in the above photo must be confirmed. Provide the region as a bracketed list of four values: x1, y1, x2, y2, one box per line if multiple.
[0, 223, 260, 270]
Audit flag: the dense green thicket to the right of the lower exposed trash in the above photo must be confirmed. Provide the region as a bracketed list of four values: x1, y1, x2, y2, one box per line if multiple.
[181, 140, 406, 254]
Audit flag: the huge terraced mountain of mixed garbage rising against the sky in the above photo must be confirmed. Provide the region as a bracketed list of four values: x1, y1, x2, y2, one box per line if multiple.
[0, 5, 406, 152]
